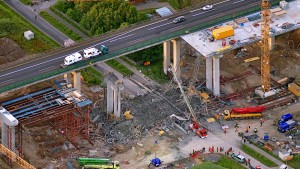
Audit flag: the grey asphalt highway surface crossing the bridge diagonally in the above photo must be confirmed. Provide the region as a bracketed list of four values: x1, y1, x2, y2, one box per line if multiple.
[0, 0, 272, 92]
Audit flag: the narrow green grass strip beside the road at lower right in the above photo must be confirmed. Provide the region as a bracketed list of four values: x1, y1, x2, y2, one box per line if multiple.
[241, 144, 278, 167]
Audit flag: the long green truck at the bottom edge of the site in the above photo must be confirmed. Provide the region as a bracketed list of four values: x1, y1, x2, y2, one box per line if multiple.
[77, 158, 120, 169]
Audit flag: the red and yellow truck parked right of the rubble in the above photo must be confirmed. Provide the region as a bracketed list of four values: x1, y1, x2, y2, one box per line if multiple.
[224, 106, 266, 120]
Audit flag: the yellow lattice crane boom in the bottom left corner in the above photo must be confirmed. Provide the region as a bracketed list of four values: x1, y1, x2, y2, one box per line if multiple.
[0, 144, 35, 169]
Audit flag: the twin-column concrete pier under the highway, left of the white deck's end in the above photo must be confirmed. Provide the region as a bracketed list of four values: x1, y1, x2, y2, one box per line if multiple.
[163, 39, 181, 80]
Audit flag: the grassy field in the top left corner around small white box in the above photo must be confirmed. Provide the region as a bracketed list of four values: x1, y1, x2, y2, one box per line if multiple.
[0, 1, 59, 54]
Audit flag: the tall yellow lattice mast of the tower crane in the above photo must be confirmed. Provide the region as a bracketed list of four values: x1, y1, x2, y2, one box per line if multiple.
[260, 0, 271, 92]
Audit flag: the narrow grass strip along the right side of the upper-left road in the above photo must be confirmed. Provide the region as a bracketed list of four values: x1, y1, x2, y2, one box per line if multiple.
[40, 11, 81, 41]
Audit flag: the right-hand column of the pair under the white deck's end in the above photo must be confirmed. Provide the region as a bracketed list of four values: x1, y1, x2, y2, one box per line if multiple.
[213, 56, 222, 96]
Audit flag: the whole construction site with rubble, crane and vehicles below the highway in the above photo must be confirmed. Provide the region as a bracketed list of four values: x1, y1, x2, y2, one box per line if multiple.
[0, 0, 300, 169]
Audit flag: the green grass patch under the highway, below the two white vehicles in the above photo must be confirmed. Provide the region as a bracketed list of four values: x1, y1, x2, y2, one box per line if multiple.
[80, 67, 105, 86]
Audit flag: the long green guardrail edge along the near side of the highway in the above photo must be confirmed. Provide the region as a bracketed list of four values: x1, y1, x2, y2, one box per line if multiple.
[0, 0, 288, 93]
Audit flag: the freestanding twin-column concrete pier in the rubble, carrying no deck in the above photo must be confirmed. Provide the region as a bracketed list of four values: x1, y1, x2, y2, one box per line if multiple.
[104, 72, 124, 118]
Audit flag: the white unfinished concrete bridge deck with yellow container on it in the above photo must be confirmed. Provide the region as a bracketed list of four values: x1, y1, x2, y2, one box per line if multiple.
[181, 0, 300, 57]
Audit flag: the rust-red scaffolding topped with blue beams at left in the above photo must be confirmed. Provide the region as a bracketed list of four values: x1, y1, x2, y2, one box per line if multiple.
[1, 87, 92, 157]
